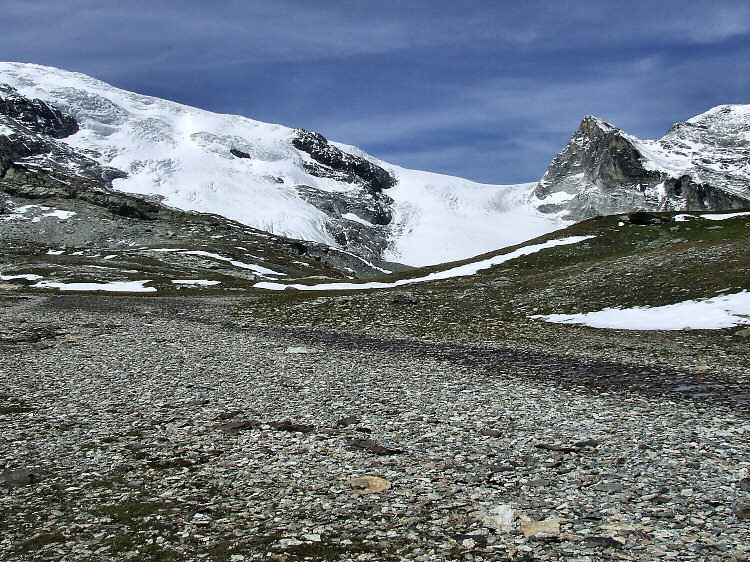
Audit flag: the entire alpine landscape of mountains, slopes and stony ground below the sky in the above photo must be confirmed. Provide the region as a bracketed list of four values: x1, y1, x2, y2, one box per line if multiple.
[0, 63, 750, 562]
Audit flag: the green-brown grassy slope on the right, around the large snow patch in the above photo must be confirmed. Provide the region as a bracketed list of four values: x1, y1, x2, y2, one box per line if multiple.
[241, 210, 750, 368]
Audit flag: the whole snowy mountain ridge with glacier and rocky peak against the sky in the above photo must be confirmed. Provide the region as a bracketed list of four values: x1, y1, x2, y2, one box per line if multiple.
[0, 63, 750, 271]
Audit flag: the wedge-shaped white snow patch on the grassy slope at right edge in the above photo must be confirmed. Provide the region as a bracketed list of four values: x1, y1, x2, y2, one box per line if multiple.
[531, 291, 750, 330]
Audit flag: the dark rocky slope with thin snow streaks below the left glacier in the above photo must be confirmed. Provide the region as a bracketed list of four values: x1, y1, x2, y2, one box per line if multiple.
[0, 153, 400, 294]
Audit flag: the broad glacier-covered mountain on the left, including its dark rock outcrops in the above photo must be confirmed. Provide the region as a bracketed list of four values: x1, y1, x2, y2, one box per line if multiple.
[0, 63, 563, 266]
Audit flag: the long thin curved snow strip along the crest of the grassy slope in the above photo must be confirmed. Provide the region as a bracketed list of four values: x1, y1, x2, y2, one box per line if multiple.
[253, 236, 594, 291]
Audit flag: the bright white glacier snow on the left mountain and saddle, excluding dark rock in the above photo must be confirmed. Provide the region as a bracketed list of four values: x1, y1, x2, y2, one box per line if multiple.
[0, 62, 565, 266]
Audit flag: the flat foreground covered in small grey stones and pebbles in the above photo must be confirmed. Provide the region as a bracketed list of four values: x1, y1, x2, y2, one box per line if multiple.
[0, 295, 750, 561]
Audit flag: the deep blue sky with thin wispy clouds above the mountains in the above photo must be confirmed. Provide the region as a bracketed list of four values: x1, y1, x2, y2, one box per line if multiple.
[0, 0, 750, 183]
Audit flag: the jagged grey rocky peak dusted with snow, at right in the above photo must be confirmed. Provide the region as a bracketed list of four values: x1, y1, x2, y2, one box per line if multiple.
[529, 105, 750, 221]
